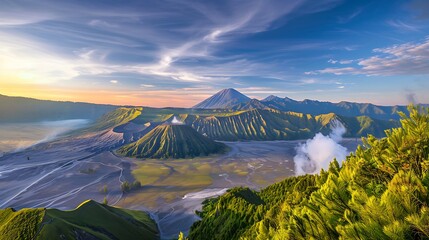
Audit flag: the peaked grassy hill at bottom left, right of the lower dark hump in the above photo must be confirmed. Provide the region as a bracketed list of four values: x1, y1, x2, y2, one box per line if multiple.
[38, 200, 159, 239]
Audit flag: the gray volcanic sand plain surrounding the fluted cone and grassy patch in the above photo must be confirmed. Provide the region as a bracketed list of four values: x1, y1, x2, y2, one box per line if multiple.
[0, 131, 360, 239]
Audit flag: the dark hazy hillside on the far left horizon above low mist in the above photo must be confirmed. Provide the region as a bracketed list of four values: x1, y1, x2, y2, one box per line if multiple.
[0, 95, 118, 123]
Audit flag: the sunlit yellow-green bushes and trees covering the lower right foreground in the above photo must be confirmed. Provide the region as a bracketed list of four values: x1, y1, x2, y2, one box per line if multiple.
[189, 107, 429, 239]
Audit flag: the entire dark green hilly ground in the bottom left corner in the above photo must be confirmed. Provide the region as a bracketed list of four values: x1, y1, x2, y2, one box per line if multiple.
[0, 200, 159, 240]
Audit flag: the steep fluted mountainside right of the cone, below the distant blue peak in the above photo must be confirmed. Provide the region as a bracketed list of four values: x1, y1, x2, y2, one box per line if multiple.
[180, 109, 398, 141]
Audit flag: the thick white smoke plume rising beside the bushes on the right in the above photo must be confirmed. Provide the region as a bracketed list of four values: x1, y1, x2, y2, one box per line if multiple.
[293, 119, 348, 175]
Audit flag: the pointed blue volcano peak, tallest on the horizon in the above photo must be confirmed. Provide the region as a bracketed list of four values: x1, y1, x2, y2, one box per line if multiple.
[193, 88, 250, 109]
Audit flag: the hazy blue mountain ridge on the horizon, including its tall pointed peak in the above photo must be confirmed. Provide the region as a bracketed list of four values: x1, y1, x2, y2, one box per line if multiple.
[195, 88, 407, 120]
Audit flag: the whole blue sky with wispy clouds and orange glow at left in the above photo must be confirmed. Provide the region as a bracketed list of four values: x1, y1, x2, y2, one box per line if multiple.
[0, 0, 429, 107]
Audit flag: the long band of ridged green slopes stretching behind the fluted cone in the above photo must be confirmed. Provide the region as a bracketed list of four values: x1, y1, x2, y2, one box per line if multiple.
[83, 108, 399, 142]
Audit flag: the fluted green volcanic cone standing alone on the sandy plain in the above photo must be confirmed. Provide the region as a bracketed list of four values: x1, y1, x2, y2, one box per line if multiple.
[117, 124, 225, 158]
